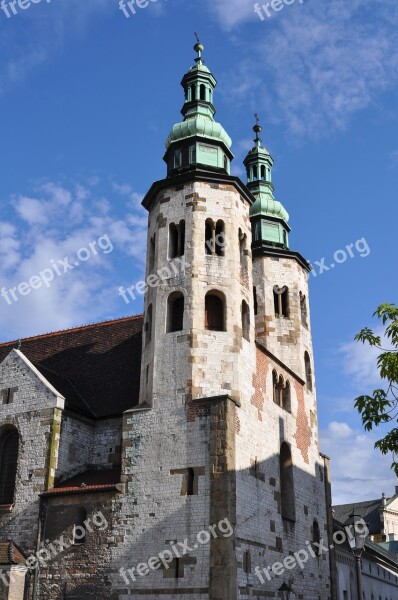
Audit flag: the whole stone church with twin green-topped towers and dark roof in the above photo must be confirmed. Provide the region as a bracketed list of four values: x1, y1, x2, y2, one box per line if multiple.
[0, 42, 335, 600]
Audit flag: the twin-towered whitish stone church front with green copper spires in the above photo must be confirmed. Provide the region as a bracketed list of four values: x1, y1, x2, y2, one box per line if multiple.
[119, 41, 329, 600]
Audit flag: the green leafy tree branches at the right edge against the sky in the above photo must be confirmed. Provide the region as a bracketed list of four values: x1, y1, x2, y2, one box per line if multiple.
[355, 304, 398, 476]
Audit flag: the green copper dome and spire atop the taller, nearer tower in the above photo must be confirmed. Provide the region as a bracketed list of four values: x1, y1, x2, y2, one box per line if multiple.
[164, 40, 233, 176]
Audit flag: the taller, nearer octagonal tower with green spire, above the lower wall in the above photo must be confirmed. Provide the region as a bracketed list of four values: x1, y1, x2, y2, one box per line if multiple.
[137, 43, 254, 406]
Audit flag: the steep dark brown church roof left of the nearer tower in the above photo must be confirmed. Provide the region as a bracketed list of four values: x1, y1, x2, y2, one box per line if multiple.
[0, 315, 143, 418]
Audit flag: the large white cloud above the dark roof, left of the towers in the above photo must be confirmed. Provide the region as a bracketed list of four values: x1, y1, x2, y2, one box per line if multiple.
[0, 181, 147, 341]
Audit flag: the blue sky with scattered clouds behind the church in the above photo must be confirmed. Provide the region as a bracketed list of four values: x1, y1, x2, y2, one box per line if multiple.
[0, 0, 398, 502]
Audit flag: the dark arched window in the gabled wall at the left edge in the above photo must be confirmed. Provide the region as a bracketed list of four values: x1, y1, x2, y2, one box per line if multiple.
[0, 428, 19, 504]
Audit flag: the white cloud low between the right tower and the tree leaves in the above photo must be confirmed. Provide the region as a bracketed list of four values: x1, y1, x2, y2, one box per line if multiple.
[320, 421, 396, 504]
